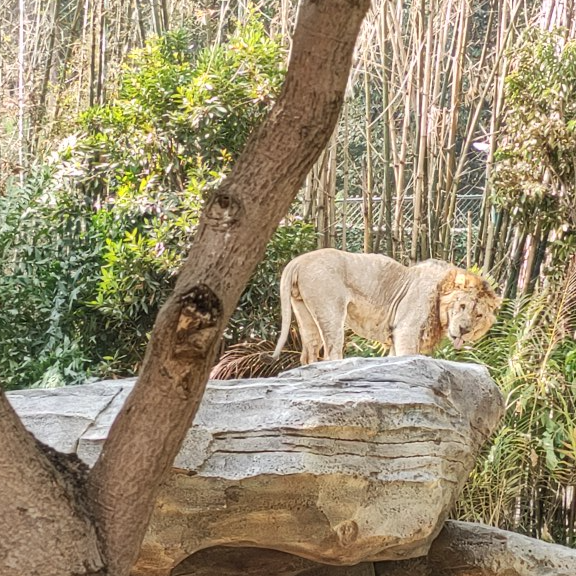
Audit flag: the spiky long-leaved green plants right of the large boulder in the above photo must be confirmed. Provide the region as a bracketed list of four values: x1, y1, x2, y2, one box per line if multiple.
[443, 284, 576, 544]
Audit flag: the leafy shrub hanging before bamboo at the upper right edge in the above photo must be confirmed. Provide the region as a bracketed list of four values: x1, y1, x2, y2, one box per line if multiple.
[493, 29, 576, 235]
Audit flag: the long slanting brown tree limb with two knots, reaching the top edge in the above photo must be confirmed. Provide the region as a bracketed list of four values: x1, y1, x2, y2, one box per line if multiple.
[90, 0, 370, 576]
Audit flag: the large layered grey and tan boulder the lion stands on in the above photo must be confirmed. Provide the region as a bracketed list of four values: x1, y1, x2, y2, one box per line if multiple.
[10, 357, 503, 575]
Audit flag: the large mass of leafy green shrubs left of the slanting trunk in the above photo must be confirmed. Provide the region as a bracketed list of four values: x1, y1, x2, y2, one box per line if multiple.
[0, 18, 286, 387]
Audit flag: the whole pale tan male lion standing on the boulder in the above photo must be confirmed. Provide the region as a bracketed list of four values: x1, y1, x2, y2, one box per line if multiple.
[272, 248, 500, 364]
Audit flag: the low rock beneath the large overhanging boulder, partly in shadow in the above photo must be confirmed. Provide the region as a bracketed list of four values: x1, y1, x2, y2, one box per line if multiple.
[171, 520, 576, 576]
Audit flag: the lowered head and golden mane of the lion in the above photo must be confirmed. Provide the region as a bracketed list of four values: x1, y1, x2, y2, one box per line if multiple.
[439, 269, 501, 349]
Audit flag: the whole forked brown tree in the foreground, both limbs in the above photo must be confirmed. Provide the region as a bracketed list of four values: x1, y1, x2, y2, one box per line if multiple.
[0, 0, 370, 576]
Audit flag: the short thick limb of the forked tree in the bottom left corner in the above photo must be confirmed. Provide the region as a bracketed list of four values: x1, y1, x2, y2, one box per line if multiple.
[0, 390, 104, 576]
